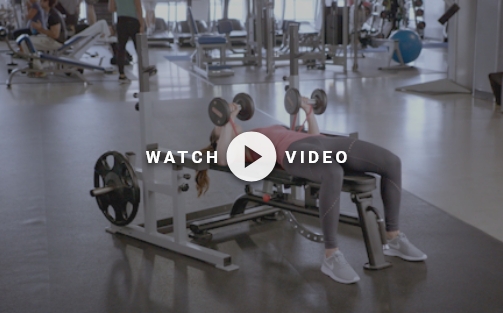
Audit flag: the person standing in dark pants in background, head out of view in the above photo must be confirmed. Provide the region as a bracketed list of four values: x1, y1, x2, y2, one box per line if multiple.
[108, 0, 144, 84]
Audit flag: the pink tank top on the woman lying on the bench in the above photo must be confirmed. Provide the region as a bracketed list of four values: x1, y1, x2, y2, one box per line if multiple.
[250, 125, 319, 166]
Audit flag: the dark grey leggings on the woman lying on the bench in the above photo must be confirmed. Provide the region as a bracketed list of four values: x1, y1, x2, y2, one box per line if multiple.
[283, 136, 402, 249]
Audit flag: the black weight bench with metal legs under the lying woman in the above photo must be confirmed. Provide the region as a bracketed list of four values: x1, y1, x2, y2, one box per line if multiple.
[189, 164, 391, 270]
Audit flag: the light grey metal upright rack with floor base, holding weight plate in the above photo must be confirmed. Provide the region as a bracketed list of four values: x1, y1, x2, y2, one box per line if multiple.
[107, 34, 238, 271]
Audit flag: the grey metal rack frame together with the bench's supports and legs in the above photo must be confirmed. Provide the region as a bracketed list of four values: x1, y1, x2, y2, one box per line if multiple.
[107, 34, 390, 271]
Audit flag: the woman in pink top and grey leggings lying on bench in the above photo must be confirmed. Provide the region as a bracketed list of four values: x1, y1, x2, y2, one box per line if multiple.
[196, 98, 426, 284]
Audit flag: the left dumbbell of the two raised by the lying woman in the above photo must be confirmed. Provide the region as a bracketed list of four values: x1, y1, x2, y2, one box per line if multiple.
[208, 93, 255, 126]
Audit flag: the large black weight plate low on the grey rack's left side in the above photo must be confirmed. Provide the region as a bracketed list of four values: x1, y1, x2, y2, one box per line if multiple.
[94, 151, 140, 226]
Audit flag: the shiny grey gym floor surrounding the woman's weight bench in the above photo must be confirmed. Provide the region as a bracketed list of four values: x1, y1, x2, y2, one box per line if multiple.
[0, 37, 503, 313]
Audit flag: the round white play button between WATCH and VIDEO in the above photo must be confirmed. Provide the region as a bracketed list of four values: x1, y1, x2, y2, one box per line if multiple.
[227, 132, 276, 182]
